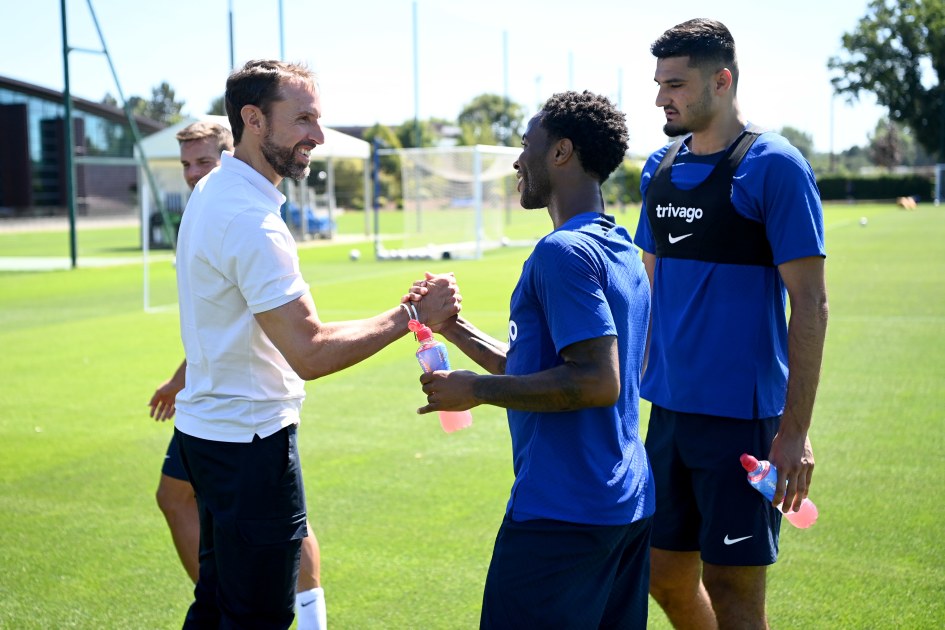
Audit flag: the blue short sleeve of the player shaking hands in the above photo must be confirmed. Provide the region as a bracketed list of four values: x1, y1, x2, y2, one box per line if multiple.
[532, 232, 617, 353]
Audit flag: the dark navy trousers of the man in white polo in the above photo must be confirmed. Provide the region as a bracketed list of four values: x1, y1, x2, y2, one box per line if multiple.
[175, 426, 306, 630]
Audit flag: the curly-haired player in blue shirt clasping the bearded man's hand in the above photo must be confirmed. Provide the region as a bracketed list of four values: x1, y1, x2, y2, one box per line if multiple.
[415, 92, 654, 629]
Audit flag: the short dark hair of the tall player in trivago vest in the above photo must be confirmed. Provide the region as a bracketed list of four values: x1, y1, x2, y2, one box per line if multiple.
[650, 18, 738, 88]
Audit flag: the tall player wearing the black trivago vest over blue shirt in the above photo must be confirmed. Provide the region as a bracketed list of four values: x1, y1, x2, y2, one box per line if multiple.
[636, 19, 827, 628]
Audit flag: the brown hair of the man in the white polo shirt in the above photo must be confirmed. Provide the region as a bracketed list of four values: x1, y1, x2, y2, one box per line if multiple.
[224, 59, 315, 144]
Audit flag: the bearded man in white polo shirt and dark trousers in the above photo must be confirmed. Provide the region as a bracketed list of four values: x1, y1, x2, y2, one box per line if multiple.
[175, 61, 461, 628]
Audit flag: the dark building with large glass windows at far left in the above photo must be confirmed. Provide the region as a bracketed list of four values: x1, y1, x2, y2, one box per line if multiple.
[0, 76, 164, 220]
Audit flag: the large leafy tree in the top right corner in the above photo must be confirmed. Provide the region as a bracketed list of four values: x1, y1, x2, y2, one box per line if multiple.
[827, 0, 945, 161]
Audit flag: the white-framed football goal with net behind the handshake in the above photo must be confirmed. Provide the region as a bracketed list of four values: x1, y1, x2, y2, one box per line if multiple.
[375, 145, 521, 260]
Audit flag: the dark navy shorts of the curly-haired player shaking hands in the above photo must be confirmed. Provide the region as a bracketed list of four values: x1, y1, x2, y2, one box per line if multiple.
[479, 516, 652, 630]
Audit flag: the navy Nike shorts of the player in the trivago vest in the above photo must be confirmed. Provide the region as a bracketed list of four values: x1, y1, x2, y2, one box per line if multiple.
[646, 405, 781, 566]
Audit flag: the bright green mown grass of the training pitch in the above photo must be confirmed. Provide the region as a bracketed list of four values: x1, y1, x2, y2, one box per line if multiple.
[0, 204, 945, 630]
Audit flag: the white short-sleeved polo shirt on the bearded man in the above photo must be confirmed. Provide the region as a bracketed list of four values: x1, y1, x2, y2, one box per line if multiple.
[175, 152, 309, 442]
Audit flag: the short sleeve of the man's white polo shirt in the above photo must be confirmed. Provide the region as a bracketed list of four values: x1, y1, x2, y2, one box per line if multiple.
[223, 212, 309, 314]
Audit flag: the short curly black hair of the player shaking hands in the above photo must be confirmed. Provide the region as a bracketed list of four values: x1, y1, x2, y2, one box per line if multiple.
[539, 90, 629, 184]
